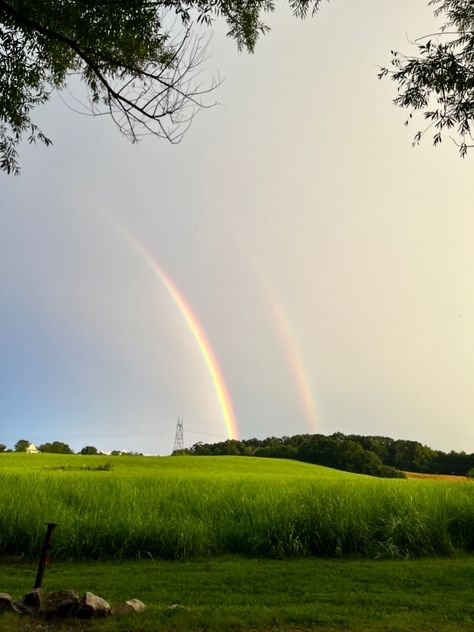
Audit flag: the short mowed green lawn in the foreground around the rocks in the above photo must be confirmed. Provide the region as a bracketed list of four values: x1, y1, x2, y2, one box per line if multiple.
[0, 556, 474, 632]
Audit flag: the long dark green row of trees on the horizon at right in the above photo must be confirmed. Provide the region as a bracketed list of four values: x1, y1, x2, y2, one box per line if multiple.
[184, 432, 474, 477]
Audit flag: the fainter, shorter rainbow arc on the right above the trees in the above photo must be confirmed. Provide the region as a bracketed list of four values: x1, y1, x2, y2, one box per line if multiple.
[261, 281, 317, 432]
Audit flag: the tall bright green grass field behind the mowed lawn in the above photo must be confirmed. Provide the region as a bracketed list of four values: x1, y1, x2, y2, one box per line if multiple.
[0, 455, 474, 559]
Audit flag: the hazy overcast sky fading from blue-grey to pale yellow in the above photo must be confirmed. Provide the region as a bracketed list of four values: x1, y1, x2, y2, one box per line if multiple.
[0, 0, 474, 454]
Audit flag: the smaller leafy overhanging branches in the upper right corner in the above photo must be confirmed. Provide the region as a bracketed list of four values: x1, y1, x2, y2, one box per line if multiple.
[379, 0, 474, 157]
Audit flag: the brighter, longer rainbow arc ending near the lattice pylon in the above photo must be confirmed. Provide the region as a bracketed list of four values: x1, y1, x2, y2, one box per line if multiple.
[112, 217, 239, 439]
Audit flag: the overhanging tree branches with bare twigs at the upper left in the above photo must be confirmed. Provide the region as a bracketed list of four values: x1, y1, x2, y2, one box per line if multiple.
[0, 0, 321, 174]
